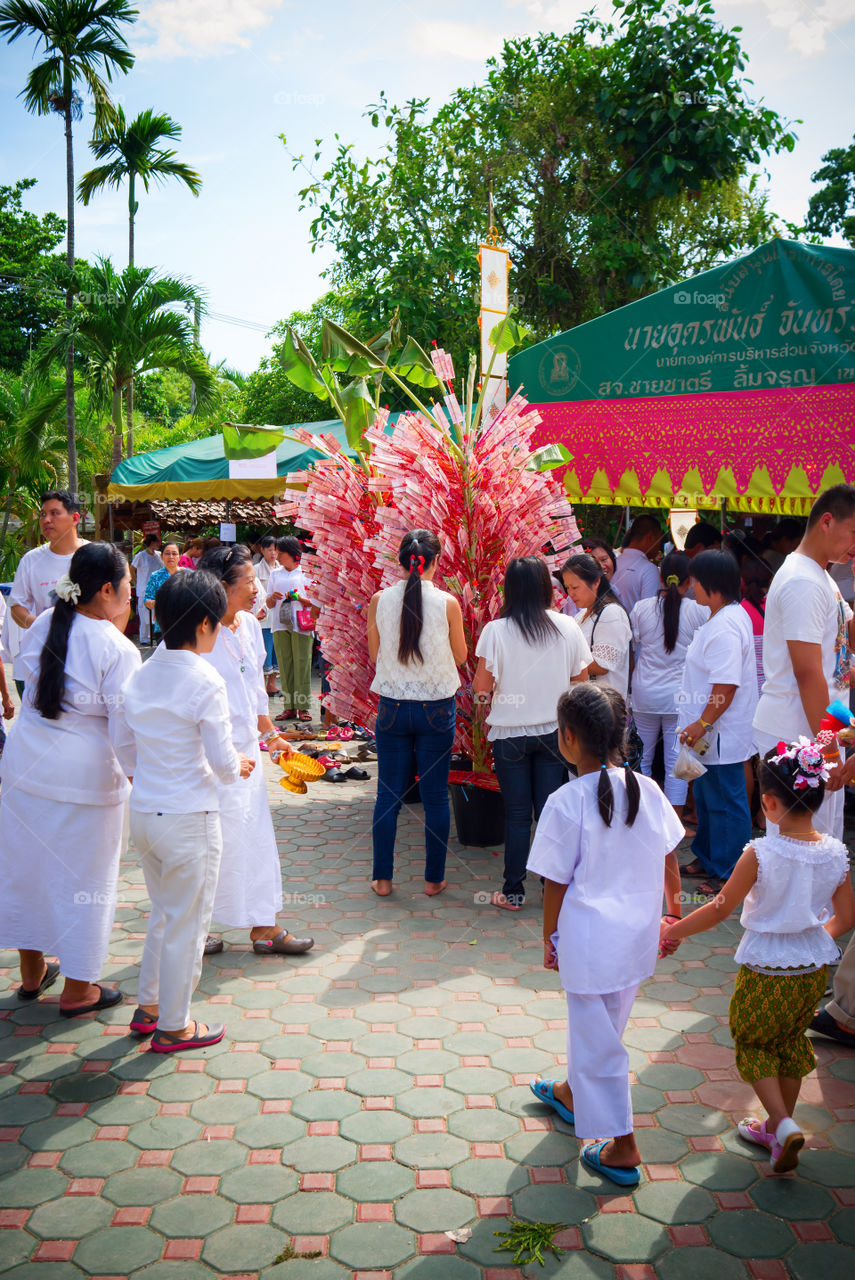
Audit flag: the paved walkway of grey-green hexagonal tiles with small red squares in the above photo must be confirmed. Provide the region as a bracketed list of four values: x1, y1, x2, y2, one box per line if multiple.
[0, 763, 855, 1280]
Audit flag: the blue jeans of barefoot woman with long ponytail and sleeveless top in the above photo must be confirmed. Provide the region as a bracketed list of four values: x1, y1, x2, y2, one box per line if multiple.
[371, 698, 454, 884]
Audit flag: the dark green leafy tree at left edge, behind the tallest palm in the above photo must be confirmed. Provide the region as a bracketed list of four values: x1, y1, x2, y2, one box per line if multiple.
[0, 178, 65, 374]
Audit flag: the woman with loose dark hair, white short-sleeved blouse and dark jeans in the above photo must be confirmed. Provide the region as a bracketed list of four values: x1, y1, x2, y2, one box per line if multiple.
[472, 556, 591, 911]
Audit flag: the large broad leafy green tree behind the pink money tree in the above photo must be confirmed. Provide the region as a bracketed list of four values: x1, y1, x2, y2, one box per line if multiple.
[283, 0, 794, 360]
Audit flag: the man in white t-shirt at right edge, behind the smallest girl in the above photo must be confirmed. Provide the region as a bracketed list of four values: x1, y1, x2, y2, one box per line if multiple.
[754, 484, 855, 840]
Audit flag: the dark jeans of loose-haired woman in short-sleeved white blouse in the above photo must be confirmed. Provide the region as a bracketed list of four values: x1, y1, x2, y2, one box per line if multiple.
[493, 730, 567, 906]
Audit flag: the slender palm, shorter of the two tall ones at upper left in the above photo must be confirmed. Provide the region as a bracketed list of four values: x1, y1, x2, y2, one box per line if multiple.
[77, 106, 202, 457]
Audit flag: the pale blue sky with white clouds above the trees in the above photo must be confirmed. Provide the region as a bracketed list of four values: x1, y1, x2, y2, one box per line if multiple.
[0, 0, 855, 371]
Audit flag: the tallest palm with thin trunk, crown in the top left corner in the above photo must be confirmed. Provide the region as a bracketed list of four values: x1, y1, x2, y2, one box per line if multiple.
[0, 0, 137, 493]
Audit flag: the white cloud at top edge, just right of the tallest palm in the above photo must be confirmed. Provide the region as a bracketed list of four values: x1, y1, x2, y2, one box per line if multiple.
[137, 0, 283, 59]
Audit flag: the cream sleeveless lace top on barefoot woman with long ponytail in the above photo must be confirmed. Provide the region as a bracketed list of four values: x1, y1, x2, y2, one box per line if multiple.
[371, 579, 461, 703]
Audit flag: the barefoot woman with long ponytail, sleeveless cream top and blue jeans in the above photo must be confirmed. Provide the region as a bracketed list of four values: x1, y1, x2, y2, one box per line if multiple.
[369, 529, 466, 897]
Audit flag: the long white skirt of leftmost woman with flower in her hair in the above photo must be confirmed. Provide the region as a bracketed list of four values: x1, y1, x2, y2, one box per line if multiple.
[0, 786, 127, 982]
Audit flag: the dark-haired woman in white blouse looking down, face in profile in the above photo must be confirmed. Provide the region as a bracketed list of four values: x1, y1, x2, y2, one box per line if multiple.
[561, 556, 632, 699]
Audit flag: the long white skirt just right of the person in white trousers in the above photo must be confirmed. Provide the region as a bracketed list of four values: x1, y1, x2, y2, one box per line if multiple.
[212, 746, 282, 929]
